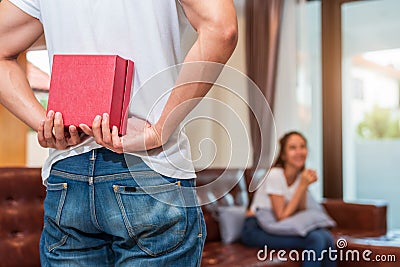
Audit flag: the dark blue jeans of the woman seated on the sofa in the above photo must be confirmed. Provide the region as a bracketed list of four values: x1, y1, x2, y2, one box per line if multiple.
[241, 217, 336, 267]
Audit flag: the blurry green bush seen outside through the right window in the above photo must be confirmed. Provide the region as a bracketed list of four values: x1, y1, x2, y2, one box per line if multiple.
[357, 106, 400, 139]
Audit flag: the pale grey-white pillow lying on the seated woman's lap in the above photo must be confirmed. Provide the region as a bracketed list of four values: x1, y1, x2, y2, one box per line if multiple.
[256, 208, 336, 236]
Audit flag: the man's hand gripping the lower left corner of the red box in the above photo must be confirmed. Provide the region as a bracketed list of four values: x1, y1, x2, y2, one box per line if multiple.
[37, 110, 83, 150]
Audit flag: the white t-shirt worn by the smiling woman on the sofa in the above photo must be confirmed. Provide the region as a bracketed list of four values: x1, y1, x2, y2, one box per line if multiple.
[250, 167, 300, 212]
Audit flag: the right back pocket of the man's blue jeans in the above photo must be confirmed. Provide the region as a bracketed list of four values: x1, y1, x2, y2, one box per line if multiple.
[113, 181, 187, 256]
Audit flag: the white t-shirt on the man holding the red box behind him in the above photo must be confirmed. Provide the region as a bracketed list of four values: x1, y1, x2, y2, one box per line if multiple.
[10, 0, 195, 183]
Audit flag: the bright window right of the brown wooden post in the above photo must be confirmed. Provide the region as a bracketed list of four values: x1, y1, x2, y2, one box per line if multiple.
[342, 0, 400, 229]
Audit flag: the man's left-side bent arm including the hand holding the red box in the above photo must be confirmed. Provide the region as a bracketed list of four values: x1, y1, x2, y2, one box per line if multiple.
[0, 0, 81, 149]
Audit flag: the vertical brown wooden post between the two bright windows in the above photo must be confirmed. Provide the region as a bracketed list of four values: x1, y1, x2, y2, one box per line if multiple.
[321, 0, 343, 198]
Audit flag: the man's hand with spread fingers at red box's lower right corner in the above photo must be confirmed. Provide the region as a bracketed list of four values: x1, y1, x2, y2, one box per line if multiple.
[79, 113, 163, 153]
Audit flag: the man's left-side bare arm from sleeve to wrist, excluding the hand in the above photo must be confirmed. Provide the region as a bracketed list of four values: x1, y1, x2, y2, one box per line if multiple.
[0, 0, 45, 130]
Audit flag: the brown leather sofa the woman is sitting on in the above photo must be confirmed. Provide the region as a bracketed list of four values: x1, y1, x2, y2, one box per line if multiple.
[0, 168, 400, 267]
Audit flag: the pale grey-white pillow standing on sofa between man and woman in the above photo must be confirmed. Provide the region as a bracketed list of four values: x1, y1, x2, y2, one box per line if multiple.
[218, 206, 246, 244]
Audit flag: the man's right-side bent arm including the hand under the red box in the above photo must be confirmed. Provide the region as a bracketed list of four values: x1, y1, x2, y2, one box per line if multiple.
[87, 0, 237, 153]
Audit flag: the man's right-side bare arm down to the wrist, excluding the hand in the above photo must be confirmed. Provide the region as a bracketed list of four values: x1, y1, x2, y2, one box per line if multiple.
[155, 0, 237, 143]
